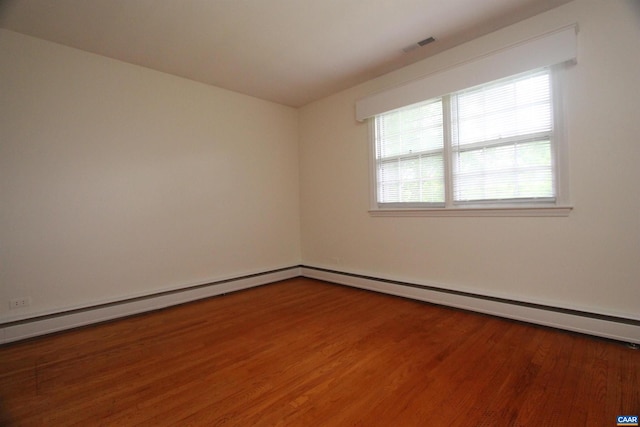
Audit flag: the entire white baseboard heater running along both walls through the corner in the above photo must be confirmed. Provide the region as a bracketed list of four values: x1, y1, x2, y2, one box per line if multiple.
[0, 265, 640, 345]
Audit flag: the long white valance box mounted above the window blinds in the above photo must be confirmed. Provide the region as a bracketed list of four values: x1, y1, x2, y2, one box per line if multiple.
[356, 25, 577, 121]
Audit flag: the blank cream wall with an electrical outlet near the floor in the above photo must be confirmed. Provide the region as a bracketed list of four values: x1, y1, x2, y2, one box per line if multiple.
[0, 30, 300, 321]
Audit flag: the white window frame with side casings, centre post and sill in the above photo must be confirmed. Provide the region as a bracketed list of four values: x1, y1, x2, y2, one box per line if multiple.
[368, 64, 573, 216]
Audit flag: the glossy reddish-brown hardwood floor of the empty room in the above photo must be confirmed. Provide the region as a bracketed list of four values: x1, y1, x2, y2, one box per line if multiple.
[0, 278, 640, 426]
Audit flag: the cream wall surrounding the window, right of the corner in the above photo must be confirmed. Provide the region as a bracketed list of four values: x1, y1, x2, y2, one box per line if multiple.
[300, 0, 640, 319]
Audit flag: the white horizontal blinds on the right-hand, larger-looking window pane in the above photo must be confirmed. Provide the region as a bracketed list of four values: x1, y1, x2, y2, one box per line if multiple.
[451, 69, 555, 203]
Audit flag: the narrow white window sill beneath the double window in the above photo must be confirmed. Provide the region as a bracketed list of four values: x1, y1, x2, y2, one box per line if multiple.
[369, 206, 573, 217]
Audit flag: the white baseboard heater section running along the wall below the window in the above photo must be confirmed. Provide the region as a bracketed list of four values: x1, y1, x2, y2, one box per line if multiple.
[301, 266, 640, 344]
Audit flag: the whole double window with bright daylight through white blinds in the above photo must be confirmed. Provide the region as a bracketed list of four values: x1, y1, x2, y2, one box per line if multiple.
[372, 67, 561, 217]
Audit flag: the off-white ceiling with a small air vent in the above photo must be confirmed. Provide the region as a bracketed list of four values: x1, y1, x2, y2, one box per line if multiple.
[0, 0, 569, 107]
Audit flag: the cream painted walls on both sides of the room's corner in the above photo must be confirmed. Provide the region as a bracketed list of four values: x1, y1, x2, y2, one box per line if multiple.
[0, 0, 640, 338]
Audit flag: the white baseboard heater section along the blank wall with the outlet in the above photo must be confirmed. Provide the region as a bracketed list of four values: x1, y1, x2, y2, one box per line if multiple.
[0, 266, 300, 344]
